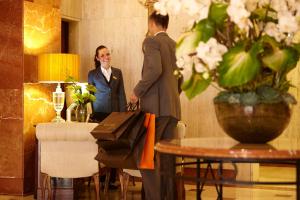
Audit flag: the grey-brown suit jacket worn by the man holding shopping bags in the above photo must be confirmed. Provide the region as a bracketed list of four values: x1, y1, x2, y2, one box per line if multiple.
[134, 32, 181, 120]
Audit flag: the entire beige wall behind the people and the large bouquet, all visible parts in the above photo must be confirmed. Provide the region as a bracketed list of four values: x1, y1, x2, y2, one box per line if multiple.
[69, 0, 300, 140]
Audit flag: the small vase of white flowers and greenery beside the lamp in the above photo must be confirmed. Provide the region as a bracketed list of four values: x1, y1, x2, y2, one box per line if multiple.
[65, 77, 97, 122]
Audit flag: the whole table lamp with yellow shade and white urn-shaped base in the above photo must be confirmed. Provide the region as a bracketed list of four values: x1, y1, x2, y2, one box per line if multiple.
[38, 53, 80, 122]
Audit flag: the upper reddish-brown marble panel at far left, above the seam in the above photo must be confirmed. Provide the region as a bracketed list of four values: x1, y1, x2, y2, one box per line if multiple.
[0, 0, 23, 89]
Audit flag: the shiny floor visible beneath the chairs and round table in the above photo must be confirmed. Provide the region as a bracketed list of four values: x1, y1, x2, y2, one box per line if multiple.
[0, 167, 296, 200]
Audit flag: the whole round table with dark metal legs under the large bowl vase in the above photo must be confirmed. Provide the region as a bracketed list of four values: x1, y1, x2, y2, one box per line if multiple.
[155, 138, 300, 200]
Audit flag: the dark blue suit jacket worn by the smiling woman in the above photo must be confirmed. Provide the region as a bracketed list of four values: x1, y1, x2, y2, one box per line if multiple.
[88, 67, 126, 113]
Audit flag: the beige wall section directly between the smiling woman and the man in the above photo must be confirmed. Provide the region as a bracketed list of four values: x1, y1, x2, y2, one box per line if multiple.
[80, 0, 147, 97]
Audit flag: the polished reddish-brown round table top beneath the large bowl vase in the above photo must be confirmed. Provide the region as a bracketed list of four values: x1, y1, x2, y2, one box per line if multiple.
[155, 137, 300, 160]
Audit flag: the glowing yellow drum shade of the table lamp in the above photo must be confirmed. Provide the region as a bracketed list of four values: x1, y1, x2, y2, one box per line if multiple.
[38, 54, 80, 82]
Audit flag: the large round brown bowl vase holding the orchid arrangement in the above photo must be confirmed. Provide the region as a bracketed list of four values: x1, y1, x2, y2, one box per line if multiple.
[214, 102, 291, 143]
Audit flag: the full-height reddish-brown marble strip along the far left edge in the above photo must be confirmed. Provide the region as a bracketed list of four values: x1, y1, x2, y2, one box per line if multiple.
[0, 0, 24, 194]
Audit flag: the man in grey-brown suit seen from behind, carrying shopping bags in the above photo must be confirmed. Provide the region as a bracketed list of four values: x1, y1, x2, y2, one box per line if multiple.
[130, 13, 181, 200]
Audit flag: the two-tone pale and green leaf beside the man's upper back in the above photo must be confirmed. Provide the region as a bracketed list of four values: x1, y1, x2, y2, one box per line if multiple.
[176, 19, 215, 57]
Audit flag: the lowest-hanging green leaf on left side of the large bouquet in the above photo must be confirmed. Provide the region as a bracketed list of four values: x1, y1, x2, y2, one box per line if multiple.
[182, 74, 211, 99]
